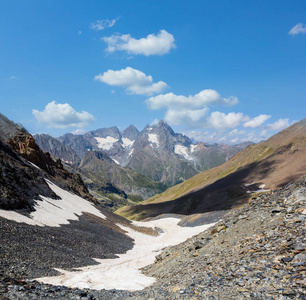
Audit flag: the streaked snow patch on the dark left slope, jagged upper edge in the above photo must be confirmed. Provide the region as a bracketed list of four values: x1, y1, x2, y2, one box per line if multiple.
[0, 180, 106, 227]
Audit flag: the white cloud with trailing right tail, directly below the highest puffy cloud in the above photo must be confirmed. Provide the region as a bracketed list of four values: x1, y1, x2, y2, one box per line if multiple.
[94, 67, 168, 95]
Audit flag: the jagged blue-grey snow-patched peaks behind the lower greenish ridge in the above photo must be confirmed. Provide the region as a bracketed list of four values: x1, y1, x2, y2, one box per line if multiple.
[59, 121, 251, 186]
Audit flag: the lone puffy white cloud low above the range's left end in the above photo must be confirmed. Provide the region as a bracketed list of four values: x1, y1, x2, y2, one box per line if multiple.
[32, 101, 94, 128]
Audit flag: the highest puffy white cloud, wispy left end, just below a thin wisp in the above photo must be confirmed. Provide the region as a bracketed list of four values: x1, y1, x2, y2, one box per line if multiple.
[101, 30, 176, 56]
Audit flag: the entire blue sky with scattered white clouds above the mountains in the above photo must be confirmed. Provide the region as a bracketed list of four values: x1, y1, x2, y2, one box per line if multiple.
[0, 0, 306, 143]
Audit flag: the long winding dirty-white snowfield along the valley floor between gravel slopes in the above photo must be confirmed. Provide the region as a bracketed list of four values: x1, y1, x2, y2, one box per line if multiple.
[36, 218, 213, 291]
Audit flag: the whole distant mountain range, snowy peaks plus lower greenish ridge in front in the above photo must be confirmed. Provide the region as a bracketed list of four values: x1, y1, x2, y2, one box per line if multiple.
[34, 121, 251, 207]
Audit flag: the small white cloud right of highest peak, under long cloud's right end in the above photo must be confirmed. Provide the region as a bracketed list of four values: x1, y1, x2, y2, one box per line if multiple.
[207, 111, 249, 129]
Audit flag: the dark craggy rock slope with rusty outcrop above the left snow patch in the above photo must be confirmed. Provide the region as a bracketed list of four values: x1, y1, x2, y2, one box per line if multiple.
[0, 115, 93, 210]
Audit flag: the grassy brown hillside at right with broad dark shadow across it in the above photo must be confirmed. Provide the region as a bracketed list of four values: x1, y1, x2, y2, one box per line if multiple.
[118, 119, 306, 219]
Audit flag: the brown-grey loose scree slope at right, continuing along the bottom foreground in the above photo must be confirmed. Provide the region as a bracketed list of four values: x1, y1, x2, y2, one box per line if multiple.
[0, 178, 306, 300]
